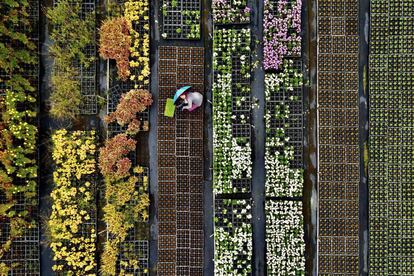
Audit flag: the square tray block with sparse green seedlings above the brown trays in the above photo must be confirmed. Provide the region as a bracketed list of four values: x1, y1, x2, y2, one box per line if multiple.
[161, 0, 201, 39]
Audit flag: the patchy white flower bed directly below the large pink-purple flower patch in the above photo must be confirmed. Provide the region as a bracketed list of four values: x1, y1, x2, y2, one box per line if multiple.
[265, 60, 303, 197]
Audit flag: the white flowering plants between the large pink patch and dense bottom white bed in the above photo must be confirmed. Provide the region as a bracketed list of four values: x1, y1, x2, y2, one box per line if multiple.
[265, 60, 303, 197]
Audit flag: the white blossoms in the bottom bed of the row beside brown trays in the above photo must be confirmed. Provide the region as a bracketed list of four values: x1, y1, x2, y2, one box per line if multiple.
[214, 200, 253, 276]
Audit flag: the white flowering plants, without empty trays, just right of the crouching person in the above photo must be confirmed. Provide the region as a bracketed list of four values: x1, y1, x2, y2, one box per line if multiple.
[213, 29, 252, 193]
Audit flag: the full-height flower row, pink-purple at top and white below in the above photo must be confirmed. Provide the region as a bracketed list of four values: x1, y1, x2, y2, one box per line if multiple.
[263, 0, 305, 275]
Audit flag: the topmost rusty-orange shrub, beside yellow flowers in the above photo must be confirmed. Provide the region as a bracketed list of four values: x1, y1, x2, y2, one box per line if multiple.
[99, 17, 131, 80]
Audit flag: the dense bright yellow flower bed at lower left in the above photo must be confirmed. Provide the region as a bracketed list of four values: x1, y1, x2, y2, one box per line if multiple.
[48, 130, 97, 275]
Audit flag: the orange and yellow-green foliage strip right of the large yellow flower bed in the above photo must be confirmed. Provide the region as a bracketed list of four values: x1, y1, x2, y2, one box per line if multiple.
[99, 134, 149, 275]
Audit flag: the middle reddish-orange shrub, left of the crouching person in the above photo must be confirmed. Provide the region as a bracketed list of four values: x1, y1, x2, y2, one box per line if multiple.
[105, 89, 152, 134]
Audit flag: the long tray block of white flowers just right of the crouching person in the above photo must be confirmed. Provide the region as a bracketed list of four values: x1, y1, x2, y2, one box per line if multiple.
[213, 28, 252, 194]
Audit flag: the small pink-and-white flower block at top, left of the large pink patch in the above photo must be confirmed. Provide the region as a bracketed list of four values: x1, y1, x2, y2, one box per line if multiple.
[213, 0, 251, 24]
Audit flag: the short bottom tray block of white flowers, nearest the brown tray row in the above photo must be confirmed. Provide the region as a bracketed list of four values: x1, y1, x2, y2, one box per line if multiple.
[214, 199, 253, 275]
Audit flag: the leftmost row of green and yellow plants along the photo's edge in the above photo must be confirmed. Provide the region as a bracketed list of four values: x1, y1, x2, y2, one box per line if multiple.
[0, 0, 38, 275]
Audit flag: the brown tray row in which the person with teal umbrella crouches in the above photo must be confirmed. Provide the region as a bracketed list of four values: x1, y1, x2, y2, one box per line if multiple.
[157, 46, 206, 275]
